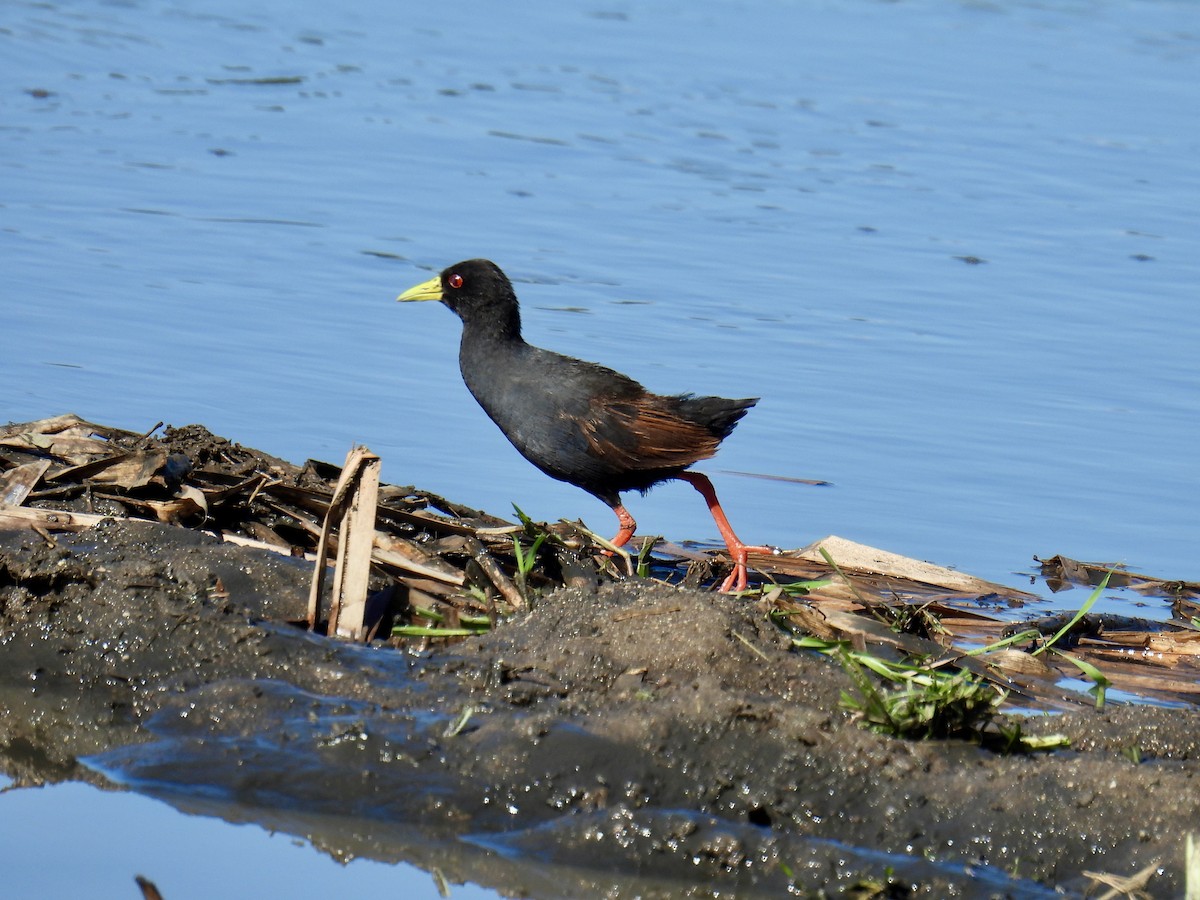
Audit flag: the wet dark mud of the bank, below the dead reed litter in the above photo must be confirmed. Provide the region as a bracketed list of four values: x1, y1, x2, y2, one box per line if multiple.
[0, 424, 1200, 898]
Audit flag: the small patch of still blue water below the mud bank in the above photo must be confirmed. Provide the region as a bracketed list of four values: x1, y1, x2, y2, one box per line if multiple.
[0, 778, 496, 900]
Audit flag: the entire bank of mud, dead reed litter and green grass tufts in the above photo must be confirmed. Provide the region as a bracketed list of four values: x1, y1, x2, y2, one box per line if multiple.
[0, 416, 1200, 898]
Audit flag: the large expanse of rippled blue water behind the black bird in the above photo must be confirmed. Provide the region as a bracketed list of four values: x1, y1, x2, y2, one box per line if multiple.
[0, 0, 1200, 897]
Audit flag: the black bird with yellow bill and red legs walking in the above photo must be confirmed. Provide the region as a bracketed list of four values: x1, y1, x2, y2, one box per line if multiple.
[397, 259, 773, 590]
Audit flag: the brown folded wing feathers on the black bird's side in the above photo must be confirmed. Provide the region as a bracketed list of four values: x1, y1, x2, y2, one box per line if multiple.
[580, 394, 720, 472]
